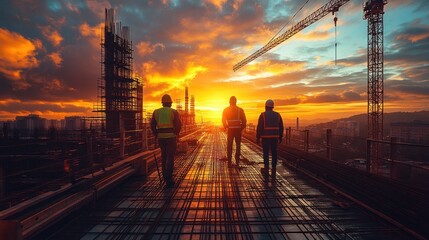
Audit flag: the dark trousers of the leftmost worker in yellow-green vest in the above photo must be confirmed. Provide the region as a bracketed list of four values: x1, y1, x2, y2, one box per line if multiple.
[158, 137, 177, 183]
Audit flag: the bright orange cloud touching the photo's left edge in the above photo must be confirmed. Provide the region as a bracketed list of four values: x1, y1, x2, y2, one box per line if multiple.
[0, 28, 42, 84]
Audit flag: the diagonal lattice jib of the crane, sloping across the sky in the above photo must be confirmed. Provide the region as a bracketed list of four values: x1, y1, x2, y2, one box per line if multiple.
[232, 0, 350, 72]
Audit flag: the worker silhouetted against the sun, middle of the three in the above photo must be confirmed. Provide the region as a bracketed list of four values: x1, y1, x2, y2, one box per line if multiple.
[222, 96, 246, 167]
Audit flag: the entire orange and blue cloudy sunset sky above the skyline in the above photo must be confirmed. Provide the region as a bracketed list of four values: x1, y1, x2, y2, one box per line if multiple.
[0, 0, 429, 125]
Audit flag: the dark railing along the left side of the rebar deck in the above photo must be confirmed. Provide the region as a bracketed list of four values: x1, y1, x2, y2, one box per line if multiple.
[0, 124, 197, 211]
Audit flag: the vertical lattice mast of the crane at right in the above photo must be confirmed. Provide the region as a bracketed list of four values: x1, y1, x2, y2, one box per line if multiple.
[363, 0, 387, 174]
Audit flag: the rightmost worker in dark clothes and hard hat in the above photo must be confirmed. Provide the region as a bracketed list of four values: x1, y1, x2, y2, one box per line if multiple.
[256, 99, 284, 179]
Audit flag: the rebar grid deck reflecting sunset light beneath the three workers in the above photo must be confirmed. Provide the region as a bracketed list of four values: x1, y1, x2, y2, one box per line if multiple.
[47, 131, 407, 239]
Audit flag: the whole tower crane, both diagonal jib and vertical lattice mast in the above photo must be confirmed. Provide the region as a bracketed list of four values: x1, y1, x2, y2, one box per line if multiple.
[233, 0, 387, 173]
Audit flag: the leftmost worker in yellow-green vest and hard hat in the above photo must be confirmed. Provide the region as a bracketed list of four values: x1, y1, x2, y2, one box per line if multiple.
[150, 94, 182, 187]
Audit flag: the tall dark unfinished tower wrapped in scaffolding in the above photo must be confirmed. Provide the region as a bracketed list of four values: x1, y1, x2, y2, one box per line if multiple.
[95, 9, 143, 137]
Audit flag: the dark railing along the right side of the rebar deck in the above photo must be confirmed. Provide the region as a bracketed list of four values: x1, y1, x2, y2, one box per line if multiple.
[246, 127, 429, 186]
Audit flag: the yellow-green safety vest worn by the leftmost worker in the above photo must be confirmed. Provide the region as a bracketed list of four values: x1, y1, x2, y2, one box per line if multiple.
[154, 107, 176, 138]
